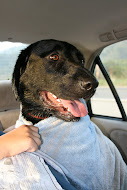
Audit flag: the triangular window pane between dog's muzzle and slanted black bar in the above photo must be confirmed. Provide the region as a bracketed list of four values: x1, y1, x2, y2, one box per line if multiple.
[91, 65, 121, 118]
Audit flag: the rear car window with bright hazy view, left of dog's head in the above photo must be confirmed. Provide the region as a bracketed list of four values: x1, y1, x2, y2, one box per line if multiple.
[0, 42, 28, 80]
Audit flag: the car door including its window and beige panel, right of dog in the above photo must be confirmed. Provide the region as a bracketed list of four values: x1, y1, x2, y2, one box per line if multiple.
[88, 41, 127, 163]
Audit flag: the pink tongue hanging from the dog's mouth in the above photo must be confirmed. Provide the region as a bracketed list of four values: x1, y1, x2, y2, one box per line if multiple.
[60, 99, 88, 117]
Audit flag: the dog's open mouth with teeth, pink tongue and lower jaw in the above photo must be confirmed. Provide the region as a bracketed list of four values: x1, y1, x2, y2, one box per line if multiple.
[40, 91, 88, 120]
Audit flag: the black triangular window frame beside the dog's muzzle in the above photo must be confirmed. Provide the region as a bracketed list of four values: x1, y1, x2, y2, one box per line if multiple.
[87, 56, 127, 121]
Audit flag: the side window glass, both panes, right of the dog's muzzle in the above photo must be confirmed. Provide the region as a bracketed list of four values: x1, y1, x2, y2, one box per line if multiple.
[91, 41, 127, 118]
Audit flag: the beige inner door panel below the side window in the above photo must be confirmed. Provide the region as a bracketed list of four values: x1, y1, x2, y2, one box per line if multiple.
[91, 117, 127, 164]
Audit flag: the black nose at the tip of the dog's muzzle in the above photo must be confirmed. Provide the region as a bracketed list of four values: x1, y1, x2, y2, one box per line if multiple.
[80, 81, 98, 91]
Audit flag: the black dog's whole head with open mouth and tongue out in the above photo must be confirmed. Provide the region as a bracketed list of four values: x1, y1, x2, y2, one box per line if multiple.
[12, 40, 98, 124]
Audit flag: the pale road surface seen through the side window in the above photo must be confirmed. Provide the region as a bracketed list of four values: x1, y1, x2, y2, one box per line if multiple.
[91, 87, 127, 118]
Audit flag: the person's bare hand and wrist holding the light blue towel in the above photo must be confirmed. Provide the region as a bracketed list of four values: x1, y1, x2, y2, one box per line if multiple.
[0, 125, 41, 159]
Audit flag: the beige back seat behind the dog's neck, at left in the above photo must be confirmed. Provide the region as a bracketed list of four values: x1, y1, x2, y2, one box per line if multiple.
[0, 80, 19, 129]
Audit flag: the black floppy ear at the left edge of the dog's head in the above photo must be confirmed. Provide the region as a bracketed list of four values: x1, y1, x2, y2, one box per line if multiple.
[12, 47, 31, 100]
